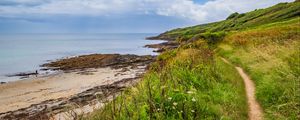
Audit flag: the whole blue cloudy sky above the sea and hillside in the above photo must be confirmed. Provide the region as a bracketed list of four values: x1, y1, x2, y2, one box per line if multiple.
[0, 0, 294, 33]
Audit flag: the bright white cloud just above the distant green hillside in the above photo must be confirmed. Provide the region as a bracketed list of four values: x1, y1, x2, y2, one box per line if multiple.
[152, 0, 293, 23]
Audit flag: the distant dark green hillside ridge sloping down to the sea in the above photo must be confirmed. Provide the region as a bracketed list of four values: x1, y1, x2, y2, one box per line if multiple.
[158, 2, 300, 41]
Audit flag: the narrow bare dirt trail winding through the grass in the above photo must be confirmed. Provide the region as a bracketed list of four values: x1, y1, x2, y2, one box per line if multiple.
[221, 58, 263, 120]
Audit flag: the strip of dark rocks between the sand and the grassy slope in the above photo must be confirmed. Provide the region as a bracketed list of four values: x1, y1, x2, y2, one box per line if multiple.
[0, 76, 140, 120]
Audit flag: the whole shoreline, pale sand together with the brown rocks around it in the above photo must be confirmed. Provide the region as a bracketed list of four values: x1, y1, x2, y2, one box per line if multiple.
[0, 54, 155, 119]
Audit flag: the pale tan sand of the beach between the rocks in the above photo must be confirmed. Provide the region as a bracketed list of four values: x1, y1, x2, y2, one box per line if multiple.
[0, 66, 145, 113]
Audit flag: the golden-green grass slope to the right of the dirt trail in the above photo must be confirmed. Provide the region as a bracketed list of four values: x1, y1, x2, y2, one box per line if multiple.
[219, 18, 300, 119]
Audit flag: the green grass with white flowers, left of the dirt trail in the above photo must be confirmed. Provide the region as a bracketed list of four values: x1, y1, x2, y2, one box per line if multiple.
[86, 45, 247, 120]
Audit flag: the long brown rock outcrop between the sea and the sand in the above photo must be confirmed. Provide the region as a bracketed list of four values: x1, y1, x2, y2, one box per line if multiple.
[42, 54, 155, 72]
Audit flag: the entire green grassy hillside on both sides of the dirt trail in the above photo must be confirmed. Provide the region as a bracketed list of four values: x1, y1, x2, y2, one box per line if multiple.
[84, 2, 300, 120]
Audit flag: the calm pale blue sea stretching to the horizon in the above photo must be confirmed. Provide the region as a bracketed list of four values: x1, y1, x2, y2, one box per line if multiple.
[0, 33, 161, 82]
